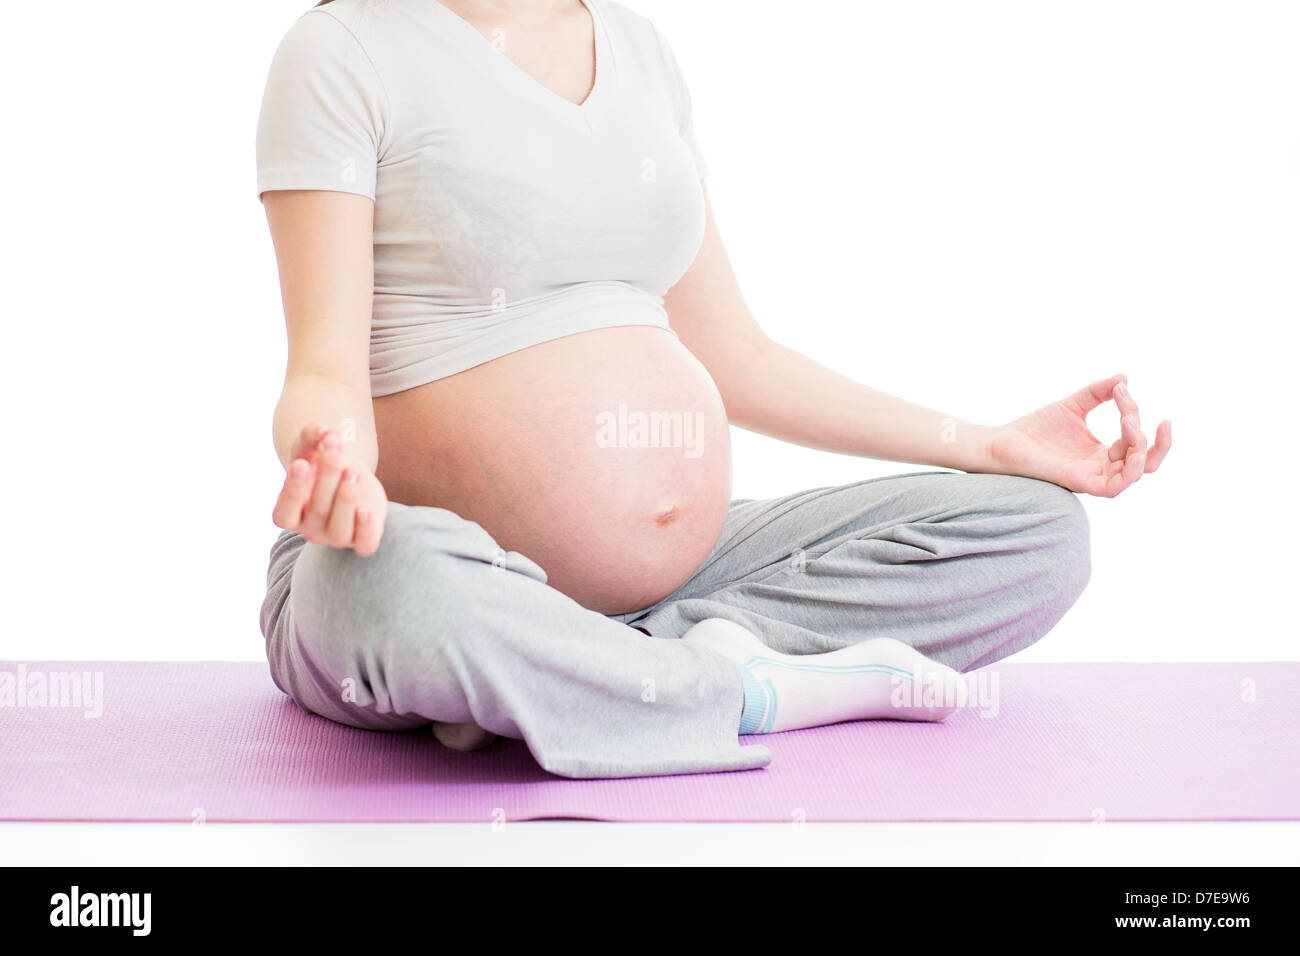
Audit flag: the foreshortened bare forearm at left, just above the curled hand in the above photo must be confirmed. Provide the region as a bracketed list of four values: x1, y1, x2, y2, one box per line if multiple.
[273, 375, 380, 473]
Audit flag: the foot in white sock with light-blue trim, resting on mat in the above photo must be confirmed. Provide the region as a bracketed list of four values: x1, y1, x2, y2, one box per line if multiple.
[683, 618, 966, 734]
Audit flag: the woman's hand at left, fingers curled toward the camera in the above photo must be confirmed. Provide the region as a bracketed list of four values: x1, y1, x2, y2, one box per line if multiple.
[272, 424, 389, 555]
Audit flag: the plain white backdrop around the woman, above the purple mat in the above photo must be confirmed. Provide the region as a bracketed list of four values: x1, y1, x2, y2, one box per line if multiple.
[0, 0, 1300, 661]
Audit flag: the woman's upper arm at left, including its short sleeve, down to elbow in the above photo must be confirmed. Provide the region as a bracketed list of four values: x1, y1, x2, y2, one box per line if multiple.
[256, 9, 390, 390]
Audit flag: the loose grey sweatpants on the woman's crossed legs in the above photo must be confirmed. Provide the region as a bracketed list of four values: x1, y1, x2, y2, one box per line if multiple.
[261, 472, 1089, 777]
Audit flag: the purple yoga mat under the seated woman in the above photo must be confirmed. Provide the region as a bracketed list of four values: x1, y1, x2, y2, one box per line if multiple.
[0, 662, 1300, 822]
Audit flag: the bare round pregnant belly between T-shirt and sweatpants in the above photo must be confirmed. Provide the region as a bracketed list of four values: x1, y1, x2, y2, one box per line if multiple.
[374, 326, 731, 614]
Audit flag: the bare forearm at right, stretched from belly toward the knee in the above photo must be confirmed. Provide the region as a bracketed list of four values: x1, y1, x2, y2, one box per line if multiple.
[714, 339, 993, 471]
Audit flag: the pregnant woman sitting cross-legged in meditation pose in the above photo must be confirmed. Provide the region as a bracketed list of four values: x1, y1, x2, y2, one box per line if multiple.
[257, 0, 1171, 777]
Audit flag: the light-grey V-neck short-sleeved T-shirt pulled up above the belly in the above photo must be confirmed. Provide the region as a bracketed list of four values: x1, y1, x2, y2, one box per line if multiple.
[256, 0, 707, 395]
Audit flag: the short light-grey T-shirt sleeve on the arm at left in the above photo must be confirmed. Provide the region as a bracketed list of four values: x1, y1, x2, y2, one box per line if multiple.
[256, 9, 387, 199]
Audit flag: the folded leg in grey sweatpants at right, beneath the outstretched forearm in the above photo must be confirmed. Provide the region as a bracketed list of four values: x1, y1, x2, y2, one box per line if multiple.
[620, 472, 1091, 671]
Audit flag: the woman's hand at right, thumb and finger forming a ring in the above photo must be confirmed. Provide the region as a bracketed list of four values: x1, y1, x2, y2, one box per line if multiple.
[988, 375, 1174, 498]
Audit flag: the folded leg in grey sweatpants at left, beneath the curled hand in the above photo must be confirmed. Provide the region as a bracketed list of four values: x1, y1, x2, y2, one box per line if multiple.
[261, 505, 771, 777]
